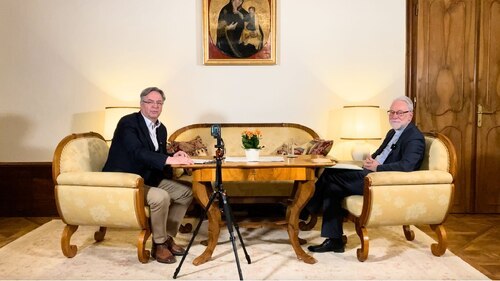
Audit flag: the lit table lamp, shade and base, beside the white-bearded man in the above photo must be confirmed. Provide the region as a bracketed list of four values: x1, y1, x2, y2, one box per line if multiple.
[340, 105, 381, 161]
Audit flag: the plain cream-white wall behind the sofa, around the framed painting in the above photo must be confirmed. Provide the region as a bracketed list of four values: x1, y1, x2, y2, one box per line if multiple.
[0, 0, 405, 162]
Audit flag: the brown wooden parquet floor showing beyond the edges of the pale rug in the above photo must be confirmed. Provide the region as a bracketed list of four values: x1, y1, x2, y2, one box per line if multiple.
[0, 214, 500, 280]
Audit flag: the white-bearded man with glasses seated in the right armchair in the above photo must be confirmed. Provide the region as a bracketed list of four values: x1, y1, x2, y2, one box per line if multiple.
[301, 96, 425, 253]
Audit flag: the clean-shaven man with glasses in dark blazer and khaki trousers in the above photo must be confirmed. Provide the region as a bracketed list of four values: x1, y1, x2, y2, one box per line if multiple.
[103, 87, 193, 263]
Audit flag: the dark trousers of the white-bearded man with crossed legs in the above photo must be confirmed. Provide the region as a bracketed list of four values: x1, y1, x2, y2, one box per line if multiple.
[306, 169, 371, 238]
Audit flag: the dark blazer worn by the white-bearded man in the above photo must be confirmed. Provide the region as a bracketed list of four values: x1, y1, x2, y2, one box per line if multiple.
[372, 123, 425, 172]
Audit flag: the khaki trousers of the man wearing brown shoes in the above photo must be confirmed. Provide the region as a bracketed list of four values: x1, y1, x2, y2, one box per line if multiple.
[144, 180, 193, 244]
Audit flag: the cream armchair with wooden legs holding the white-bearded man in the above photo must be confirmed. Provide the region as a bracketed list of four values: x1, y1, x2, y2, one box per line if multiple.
[343, 133, 457, 261]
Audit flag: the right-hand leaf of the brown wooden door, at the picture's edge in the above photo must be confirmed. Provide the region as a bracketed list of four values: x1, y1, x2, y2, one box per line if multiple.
[475, 0, 500, 213]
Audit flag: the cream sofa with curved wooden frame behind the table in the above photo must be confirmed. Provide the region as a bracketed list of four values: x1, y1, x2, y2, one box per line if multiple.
[168, 123, 333, 203]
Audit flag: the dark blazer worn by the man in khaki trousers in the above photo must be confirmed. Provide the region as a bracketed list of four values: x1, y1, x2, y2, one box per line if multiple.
[102, 112, 171, 186]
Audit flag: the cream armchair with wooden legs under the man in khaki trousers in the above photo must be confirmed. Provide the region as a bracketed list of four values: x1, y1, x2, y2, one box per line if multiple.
[52, 132, 151, 263]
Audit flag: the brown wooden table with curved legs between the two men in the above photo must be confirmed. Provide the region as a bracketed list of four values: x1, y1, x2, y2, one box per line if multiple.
[172, 155, 334, 265]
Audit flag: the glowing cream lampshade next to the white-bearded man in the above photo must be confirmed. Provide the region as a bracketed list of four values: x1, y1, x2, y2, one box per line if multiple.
[340, 105, 381, 140]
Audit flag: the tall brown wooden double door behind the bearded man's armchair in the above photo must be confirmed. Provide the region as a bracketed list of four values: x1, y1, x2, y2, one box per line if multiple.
[408, 0, 500, 212]
